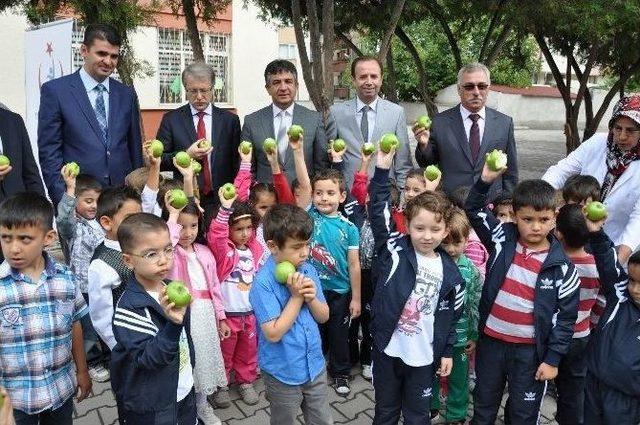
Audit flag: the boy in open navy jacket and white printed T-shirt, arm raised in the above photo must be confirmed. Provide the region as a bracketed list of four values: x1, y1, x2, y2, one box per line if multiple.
[369, 149, 465, 425]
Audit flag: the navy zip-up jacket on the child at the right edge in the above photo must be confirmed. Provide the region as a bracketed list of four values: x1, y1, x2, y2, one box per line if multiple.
[587, 230, 640, 397]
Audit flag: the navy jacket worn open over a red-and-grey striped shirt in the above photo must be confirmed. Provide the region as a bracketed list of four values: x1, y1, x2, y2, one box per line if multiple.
[464, 179, 580, 367]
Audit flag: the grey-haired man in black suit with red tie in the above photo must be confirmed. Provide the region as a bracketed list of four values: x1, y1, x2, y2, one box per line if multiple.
[156, 62, 240, 208]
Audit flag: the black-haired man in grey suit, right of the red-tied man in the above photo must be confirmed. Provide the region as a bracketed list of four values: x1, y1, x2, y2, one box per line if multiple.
[241, 60, 329, 183]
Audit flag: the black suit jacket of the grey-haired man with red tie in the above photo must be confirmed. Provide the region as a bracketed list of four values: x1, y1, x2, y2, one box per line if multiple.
[156, 103, 240, 199]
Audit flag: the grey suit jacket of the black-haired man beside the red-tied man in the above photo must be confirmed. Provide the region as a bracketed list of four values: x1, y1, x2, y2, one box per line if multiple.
[242, 103, 329, 184]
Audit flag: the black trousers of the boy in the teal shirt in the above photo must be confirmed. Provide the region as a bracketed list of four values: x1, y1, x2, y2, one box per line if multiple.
[320, 291, 351, 378]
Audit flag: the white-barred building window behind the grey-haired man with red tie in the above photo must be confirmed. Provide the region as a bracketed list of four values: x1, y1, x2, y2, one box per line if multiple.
[158, 28, 231, 104]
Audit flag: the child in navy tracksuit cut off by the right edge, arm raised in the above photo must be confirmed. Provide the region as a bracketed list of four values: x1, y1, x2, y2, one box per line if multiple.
[584, 215, 640, 425]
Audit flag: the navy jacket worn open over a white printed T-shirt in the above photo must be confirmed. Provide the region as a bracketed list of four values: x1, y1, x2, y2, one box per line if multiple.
[369, 168, 465, 365]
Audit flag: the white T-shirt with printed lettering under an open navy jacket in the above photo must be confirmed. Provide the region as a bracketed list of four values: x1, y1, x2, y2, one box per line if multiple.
[384, 252, 442, 367]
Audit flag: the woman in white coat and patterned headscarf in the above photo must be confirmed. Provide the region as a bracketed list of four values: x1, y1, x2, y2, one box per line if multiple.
[542, 95, 640, 264]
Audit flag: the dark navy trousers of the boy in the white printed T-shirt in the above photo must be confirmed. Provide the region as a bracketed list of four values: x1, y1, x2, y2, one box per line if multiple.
[372, 347, 434, 425]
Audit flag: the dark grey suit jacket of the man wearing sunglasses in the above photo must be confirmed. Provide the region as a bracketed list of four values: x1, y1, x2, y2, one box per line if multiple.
[416, 105, 518, 200]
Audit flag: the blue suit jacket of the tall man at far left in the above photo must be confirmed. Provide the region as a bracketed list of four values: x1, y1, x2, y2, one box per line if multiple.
[38, 72, 143, 204]
